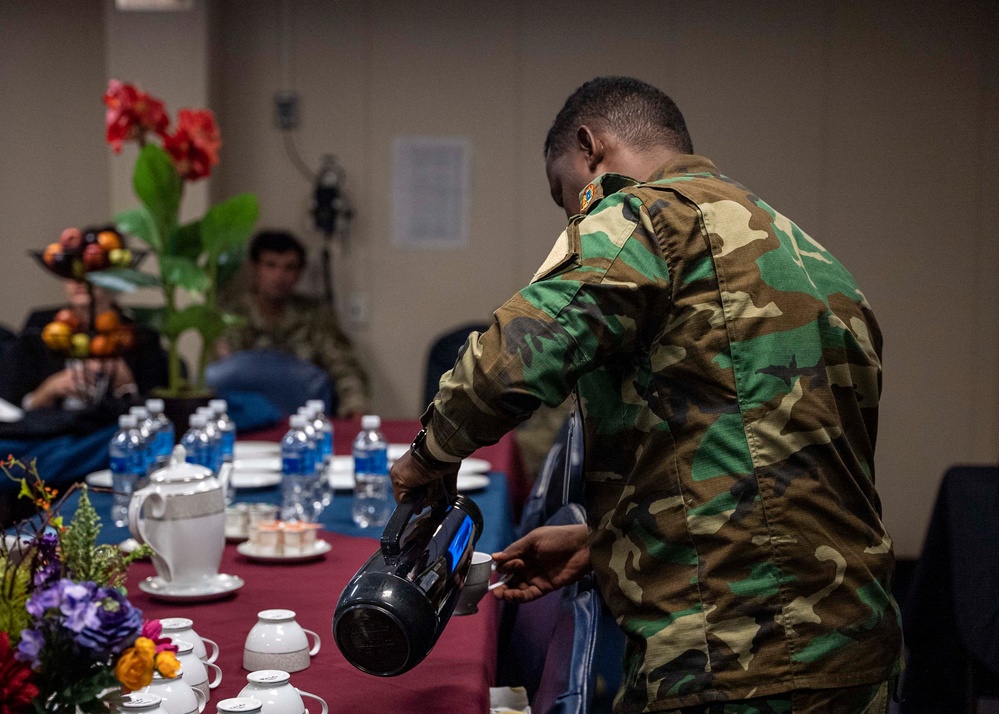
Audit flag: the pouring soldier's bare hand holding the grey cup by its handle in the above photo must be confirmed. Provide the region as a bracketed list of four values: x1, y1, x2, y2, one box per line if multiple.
[493, 525, 590, 602]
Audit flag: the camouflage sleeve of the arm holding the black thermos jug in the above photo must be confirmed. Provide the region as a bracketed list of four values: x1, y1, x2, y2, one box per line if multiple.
[423, 193, 669, 459]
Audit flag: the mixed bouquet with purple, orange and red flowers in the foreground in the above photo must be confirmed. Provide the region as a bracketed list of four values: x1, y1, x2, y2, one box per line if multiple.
[0, 457, 180, 714]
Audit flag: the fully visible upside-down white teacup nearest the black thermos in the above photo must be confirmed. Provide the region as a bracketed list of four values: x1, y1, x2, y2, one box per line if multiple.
[243, 610, 320, 672]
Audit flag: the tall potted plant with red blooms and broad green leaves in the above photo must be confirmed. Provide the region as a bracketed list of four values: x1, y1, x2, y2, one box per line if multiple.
[87, 80, 259, 397]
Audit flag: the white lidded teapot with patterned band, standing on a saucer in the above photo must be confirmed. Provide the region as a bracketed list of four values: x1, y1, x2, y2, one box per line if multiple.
[128, 445, 232, 586]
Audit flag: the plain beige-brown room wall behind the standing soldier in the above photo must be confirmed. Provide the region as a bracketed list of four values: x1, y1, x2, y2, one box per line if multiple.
[0, 0, 999, 556]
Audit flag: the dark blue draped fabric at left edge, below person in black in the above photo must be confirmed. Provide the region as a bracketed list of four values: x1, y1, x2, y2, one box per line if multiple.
[0, 425, 117, 492]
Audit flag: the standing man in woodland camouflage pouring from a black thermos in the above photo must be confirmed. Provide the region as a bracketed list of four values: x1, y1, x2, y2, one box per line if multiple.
[392, 78, 901, 713]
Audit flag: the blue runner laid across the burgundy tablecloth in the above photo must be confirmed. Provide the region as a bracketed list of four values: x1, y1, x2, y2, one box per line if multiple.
[63, 464, 513, 553]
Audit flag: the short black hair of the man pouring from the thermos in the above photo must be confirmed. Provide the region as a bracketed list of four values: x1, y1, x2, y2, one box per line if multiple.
[545, 77, 694, 158]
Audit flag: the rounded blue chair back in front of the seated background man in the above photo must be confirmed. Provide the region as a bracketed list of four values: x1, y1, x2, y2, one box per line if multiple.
[205, 349, 338, 414]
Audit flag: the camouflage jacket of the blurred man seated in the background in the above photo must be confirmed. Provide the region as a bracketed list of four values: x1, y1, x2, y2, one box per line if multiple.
[223, 293, 368, 417]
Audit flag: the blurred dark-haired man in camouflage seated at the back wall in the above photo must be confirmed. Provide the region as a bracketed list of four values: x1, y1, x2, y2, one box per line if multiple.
[218, 231, 370, 418]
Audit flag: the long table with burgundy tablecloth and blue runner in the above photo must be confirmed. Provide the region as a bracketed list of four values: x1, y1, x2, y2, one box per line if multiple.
[57, 420, 519, 714]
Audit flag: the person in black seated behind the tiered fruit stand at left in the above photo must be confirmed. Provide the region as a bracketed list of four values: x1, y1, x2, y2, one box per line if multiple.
[0, 280, 168, 410]
